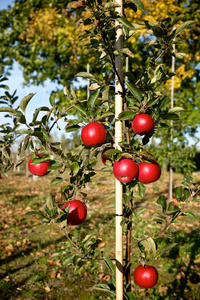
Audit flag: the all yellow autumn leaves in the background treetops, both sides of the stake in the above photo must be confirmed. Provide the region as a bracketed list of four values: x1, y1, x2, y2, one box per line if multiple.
[19, 0, 199, 88]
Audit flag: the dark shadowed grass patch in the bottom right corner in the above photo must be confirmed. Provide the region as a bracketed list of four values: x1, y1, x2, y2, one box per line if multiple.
[157, 228, 200, 300]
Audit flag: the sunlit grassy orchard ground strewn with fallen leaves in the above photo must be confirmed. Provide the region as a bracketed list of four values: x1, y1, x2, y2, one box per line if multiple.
[0, 168, 200, 300]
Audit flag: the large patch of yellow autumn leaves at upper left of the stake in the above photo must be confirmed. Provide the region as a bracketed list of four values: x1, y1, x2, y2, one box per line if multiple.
[19, 8, 89, 53]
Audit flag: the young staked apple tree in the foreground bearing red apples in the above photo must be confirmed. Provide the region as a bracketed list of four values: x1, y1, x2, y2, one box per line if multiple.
[0, 0, 198, 299]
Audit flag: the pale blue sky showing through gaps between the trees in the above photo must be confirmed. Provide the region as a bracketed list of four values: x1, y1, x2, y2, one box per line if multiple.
[0, 0, 200, 148]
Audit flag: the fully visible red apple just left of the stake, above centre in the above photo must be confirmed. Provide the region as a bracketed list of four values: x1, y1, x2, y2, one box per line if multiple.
[81, 122, 106, 147]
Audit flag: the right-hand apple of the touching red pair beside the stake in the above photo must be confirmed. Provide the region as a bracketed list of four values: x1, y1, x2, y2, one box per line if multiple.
[137, 161, 161, 183]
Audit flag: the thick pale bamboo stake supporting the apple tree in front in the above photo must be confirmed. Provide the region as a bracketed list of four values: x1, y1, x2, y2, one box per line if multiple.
[115, 0, 123, 300]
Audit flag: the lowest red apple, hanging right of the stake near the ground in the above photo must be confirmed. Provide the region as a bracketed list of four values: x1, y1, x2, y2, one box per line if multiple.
[133, 265, 158, 289]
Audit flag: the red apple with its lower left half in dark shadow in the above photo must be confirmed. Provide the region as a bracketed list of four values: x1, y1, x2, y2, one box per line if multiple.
[62, 200, 87, 225]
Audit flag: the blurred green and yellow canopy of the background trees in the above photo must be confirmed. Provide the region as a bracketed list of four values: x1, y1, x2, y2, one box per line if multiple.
[0, 0, 200, 133]
